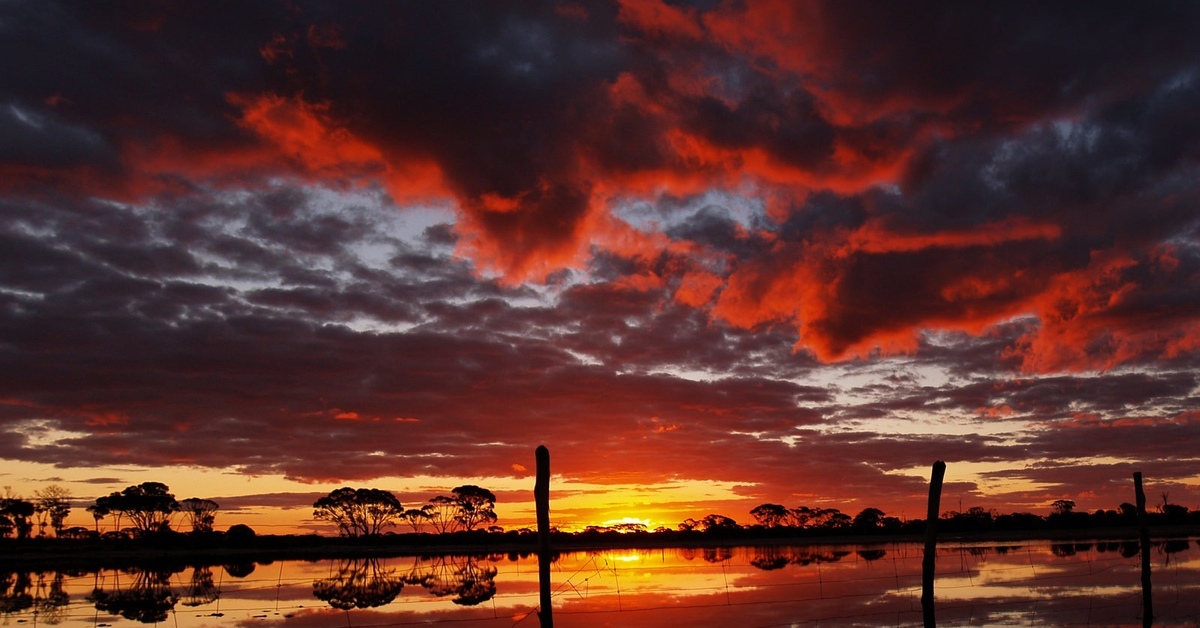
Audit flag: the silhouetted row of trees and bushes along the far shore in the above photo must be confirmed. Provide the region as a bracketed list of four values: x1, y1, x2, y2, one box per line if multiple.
[0, 482, 1200, 539]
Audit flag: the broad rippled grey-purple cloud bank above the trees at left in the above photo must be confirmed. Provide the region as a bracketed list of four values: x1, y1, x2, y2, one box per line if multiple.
[0, 184, 828, 489]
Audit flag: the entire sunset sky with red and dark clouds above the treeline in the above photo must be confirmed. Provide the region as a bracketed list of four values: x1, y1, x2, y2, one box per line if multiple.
[0, 0, 1200, 532]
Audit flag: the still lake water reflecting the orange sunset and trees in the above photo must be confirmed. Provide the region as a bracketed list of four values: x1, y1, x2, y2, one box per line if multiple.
[0, 539, 1200, 628]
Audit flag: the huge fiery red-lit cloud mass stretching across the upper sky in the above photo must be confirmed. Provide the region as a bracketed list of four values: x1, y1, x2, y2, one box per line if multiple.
[0, 0, 1200, 381]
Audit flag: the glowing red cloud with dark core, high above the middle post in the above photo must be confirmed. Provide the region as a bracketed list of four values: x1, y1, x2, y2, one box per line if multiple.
[713, 220, 1058, 360]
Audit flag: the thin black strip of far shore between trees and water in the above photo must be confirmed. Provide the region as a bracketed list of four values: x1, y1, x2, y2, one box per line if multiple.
[0, 525, 1200, 569]
